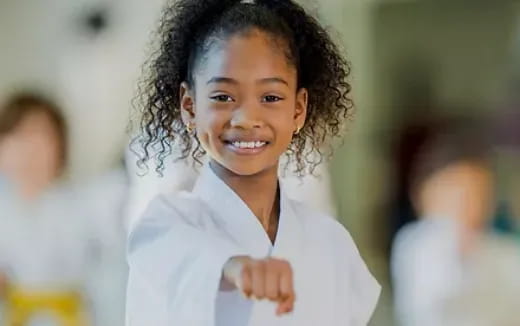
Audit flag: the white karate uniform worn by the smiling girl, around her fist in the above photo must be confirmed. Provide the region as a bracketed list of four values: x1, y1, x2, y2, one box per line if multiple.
[126, 166, 380, 326]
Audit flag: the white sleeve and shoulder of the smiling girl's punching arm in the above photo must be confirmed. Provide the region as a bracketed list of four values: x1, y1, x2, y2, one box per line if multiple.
[126, 196, 248, 326]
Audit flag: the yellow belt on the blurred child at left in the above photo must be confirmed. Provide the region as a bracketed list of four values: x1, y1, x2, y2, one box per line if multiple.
[5, 287, 87, 326]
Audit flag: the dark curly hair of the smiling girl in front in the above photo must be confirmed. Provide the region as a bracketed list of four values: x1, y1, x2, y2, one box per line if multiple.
[134, 0, 353, 175]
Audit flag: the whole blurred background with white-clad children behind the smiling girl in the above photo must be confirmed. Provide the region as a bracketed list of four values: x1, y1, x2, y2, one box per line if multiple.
[0, 0, 520, 326]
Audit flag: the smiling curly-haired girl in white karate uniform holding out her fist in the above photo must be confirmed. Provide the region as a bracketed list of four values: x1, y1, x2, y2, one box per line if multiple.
[127, 0, 380, 326]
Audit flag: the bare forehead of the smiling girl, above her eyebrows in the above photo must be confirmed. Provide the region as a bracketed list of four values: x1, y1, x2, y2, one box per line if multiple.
[195, 31, 296, 83]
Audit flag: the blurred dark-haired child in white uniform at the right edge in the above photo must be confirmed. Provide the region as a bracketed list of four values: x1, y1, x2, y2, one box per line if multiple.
[391, 126, 520, 326]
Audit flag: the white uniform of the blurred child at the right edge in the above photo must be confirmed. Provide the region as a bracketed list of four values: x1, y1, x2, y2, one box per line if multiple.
[391, 217, 520, 326]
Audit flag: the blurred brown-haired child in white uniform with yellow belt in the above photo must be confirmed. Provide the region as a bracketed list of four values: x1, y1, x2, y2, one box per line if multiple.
[0, 94, 126, 326]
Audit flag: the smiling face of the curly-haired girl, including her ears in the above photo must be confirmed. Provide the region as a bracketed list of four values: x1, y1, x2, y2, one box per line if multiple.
[181, 30, 307, 175]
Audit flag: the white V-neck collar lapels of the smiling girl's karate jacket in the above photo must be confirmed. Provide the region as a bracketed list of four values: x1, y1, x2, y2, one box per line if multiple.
[193, 164, 303, 258]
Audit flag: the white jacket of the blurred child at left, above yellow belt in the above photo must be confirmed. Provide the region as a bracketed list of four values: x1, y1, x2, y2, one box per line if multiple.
[0, 173, 126, 291]
